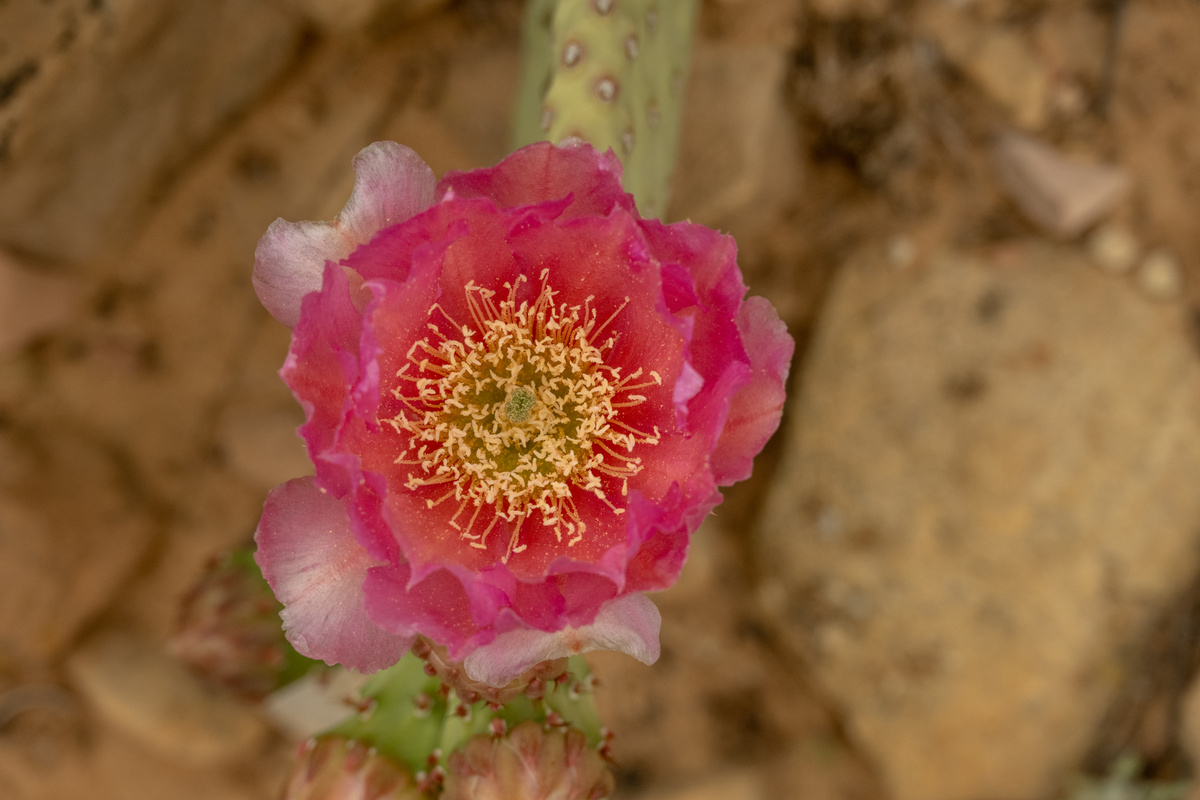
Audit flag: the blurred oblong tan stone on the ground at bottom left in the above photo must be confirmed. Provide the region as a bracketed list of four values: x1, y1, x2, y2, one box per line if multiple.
[67, 631, 266, 768]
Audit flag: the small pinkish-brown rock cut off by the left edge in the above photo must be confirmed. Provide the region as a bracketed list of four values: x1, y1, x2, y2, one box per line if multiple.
[0, 251, 82, 354]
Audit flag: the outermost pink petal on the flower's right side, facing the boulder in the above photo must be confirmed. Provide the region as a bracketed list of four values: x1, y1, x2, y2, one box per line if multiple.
[712, 297, 796, 486]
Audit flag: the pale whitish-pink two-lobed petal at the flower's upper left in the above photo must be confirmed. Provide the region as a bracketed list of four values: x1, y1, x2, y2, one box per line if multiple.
[253, 142, 436, 327]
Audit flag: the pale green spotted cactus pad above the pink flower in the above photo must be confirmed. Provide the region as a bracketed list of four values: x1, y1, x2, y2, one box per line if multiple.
[514, 0, 696, 217]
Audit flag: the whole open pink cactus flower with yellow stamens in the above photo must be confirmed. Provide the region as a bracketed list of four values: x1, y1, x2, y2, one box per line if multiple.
[254, 142, 793, 686]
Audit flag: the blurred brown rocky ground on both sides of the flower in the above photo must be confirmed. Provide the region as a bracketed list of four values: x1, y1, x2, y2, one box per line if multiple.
[0, 0, 1200, 800]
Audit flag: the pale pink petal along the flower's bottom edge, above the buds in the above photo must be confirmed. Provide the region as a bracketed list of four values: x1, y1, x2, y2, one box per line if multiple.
[463, 593, 662, 686]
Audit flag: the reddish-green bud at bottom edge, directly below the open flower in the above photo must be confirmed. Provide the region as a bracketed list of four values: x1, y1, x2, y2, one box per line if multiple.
[442, 721, 613, 800]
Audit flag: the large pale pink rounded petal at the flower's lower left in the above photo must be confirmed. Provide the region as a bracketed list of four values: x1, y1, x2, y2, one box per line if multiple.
[254, 477, 415, 672]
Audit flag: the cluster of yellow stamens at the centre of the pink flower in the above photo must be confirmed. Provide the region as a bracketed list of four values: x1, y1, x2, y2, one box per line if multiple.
[388, 271, 662, 561]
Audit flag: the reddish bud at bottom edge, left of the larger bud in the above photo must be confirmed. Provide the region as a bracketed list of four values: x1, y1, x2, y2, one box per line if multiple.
[283, 735, 425, 800]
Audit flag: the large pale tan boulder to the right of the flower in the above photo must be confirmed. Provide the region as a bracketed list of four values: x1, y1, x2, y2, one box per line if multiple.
[760, 246, 1200, 800]
